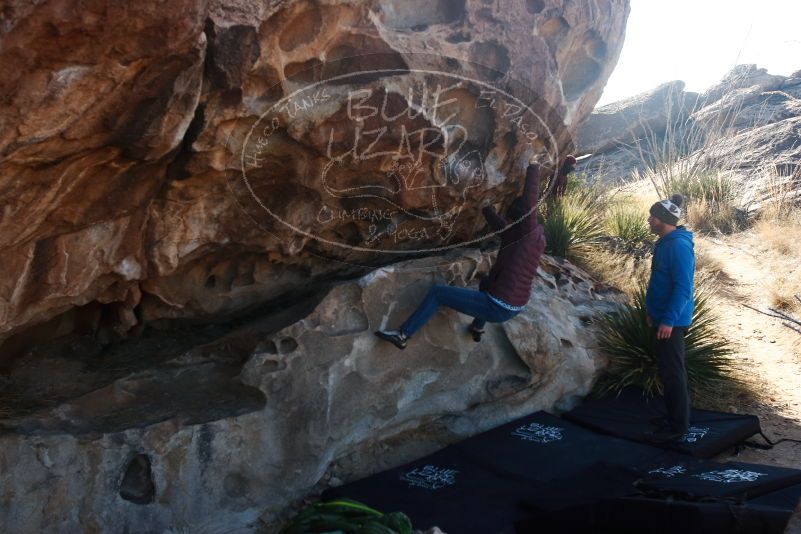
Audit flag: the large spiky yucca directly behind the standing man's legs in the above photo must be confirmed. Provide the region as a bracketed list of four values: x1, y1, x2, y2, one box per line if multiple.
[595, 281, 739, 399]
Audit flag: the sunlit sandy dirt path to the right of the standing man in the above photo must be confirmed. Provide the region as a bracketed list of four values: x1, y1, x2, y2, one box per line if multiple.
[695, 232, 801, 468]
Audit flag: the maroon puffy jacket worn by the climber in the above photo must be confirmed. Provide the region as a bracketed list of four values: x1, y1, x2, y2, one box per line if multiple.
[479, 165, 545, 306]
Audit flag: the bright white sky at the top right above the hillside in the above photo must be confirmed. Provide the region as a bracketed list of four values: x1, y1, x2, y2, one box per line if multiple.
[598, 0, 801, 106]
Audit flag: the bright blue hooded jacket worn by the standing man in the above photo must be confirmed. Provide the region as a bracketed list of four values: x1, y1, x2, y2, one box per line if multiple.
[645, 226, 695, 326]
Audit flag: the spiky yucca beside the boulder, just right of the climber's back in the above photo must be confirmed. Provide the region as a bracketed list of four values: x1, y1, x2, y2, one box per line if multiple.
[542, 188, 604, 258]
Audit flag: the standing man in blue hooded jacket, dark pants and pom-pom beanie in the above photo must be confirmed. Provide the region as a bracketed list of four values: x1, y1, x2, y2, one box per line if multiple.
[645, 195, 695, 443]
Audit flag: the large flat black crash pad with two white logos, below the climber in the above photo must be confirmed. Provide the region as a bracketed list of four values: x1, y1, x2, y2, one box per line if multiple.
[323, 412, 698, 533]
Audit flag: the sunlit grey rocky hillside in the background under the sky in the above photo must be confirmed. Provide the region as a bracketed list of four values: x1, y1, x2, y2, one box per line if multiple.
[578, 65, 801, 194]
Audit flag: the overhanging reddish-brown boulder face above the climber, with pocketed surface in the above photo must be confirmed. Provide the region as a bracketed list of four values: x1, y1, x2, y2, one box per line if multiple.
[0, 0, 629, 360]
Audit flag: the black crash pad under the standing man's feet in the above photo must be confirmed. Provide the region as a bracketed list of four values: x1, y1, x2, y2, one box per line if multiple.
[563, 388, 760, 458]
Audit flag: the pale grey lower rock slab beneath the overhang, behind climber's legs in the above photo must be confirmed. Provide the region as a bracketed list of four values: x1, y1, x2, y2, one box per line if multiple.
[0, 251, 615, 534]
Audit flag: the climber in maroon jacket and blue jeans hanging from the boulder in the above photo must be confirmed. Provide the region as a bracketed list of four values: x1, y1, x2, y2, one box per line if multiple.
[375, 162, 545, 349]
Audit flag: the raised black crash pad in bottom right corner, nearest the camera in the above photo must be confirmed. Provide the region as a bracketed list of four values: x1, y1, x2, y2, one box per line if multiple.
[515, 462, 801, 534]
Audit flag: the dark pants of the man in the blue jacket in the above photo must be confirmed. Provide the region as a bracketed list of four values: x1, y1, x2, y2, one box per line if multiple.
[655, 326, 690, 433]
